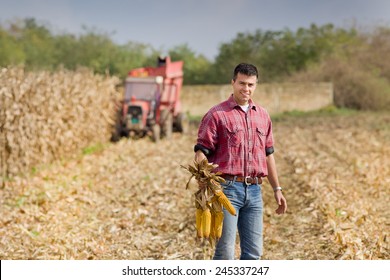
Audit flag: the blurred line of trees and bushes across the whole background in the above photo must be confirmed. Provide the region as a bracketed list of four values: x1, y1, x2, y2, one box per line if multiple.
[0, 18, 390, 109]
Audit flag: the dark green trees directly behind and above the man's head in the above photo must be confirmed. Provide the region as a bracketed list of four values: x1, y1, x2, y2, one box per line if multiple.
[215, 24, 356, 82]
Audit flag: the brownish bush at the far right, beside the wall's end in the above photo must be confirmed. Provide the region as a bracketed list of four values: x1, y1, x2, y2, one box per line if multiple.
[290, 27, 390, 110]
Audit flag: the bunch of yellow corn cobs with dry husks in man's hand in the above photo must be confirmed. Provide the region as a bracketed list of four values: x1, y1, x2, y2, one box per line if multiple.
[182, 159, 236, 242]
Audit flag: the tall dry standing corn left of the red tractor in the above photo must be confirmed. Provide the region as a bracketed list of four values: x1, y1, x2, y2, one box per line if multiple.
[0, 67, 118, 178]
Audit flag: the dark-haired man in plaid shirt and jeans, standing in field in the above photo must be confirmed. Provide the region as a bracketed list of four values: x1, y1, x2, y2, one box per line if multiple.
[194, 63, 287, 260]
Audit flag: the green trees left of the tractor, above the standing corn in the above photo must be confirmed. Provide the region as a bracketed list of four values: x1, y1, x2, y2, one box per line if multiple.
[0, 19, 158, 78]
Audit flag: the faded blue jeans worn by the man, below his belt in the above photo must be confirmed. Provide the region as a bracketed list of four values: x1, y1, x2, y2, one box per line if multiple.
[214, 178, 263, 260]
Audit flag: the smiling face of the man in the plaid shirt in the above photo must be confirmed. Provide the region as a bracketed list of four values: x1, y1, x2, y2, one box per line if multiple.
[232, 73, 257, 105]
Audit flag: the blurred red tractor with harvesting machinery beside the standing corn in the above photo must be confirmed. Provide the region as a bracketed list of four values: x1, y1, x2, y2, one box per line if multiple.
[112, 57, 188, 141]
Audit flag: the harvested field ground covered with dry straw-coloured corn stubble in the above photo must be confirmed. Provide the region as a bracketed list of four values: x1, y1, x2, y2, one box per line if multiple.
[0, 110, 390, 260]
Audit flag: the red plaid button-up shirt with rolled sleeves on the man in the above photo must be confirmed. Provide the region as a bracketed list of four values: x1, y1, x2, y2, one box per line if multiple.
[197, 95, 274, 177]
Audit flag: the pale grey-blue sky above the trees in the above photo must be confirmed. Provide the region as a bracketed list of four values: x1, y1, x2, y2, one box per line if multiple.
[0, 0, 390, 59]
